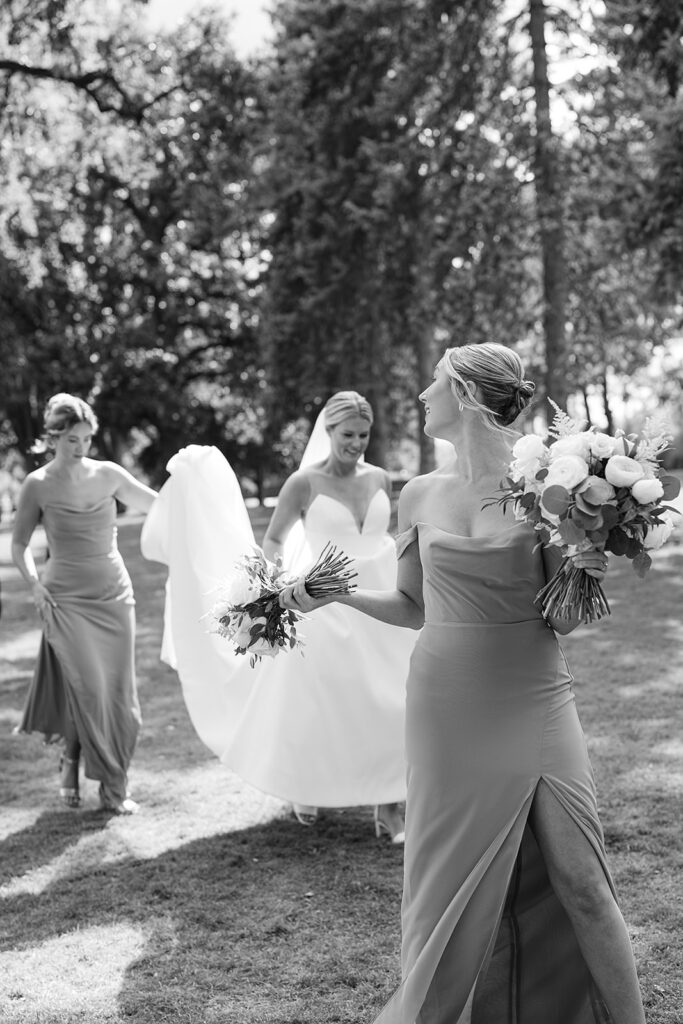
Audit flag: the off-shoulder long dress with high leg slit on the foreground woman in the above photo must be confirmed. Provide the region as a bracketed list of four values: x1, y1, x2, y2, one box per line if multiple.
[377, 523, 611, 1024]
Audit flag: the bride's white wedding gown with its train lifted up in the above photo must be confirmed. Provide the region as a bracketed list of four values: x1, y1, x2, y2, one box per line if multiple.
[141, 445, 418, 807]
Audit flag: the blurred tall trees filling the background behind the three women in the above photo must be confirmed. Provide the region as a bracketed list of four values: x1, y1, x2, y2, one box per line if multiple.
[0, 0, 683, 497]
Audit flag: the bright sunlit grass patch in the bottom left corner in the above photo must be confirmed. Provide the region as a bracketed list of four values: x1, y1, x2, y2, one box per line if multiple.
[0, 923, 144, 1024]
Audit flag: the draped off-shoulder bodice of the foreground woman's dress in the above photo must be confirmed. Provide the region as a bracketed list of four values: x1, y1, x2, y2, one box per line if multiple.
[397, 522, 546, 623]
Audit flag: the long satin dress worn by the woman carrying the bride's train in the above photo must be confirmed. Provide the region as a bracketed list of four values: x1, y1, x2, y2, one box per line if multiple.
[18, 498, 140, 804]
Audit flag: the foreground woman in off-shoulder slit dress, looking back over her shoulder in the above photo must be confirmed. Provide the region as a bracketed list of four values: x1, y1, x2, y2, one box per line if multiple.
[281, 344, 645, 1024]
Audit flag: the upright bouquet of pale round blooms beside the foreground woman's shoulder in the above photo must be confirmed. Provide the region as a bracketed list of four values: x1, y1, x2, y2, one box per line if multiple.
[494, 400, 680, 622]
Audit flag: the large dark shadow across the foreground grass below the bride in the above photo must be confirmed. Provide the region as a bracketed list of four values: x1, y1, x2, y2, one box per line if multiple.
[1, 810, 402, 1024]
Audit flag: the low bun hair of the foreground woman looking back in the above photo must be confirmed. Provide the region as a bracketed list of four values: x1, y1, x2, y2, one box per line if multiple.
[441, 341, 536, 430]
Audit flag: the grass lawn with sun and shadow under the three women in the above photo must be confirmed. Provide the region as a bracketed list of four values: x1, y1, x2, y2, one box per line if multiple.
[0, 519, 683, 1024]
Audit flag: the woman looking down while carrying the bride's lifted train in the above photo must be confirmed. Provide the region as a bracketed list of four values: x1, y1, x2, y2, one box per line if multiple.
[12, 393, 156, 814]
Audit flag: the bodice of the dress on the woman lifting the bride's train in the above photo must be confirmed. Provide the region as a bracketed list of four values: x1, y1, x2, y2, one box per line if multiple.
[42, 498, 118, 561]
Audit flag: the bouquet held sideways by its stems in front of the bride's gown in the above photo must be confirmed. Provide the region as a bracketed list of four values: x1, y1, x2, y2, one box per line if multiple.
[209, 544, 357, 668]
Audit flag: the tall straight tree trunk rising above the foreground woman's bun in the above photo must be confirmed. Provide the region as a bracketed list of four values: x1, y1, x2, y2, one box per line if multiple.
[529, 0, 567, 409]
